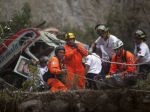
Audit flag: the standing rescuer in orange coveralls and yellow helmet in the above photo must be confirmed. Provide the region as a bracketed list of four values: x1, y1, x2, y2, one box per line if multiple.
[64, 32, 88, 89]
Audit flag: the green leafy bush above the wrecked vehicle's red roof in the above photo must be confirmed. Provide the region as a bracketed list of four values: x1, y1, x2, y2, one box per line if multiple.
[0, 3, 31, 39]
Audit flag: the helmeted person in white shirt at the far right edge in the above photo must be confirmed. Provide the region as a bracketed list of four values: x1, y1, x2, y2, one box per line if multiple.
[134, 29, 150, 78]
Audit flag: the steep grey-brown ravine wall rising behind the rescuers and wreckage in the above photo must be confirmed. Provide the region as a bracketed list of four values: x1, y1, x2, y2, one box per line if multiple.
[0, 0, 150, 46]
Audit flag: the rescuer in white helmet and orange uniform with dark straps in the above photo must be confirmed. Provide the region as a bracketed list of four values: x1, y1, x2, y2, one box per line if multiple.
[109, 40, 136, 85]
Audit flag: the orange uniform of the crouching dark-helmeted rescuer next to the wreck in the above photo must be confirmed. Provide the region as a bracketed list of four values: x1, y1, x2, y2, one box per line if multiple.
[47, 56, 67, 91]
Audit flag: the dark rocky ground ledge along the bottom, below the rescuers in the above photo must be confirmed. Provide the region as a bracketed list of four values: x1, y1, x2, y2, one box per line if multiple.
[0, 89, 150, 112]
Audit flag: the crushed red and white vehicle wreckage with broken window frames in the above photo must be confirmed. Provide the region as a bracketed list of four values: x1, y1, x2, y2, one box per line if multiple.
[0, 28, 65, 88]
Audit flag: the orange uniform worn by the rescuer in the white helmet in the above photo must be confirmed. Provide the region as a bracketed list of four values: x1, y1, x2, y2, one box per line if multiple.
[109, 50, 136, 74]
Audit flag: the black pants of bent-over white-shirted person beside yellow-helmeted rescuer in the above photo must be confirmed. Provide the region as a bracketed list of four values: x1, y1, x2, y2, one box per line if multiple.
[86, 73, 98, 89]
